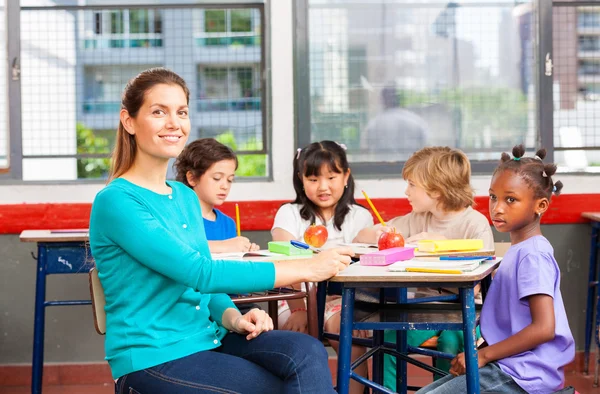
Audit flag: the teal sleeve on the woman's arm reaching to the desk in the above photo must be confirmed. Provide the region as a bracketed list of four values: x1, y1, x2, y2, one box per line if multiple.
[90, 186, 275, 294]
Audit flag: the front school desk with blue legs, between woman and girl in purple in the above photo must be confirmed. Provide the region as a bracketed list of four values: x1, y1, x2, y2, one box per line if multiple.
[330, 260, 500, 394]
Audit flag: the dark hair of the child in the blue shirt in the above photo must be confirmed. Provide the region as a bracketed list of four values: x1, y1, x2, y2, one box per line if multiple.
[173, 138, 238, 188]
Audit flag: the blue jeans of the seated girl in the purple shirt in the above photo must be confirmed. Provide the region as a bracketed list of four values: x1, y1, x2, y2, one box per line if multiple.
[416, 363, 527, 394]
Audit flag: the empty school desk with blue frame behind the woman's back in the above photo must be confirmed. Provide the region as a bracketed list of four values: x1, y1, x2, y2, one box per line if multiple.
[20, 229, 94, 394]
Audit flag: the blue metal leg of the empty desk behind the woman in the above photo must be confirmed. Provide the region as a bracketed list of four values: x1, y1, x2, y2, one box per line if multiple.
[31, 246, 46, 394]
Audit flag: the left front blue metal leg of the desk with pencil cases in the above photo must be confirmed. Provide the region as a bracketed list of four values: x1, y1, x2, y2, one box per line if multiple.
[337, 286, 355, 394]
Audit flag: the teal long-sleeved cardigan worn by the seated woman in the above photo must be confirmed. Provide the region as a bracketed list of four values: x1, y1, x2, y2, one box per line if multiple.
[90, 178, 275, 379]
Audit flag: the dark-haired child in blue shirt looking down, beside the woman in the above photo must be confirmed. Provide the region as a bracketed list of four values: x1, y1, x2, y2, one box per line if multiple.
[175, 138, 259, 253]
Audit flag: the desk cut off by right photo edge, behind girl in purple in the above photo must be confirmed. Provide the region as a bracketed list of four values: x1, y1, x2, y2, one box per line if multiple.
[581, 212, 600, 378]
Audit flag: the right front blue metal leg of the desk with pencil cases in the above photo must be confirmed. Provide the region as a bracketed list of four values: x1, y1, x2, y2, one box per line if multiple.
[460, 287, 479, 394]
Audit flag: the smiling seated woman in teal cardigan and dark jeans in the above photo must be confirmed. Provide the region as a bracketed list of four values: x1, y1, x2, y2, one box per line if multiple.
[90, 68, 352, 394]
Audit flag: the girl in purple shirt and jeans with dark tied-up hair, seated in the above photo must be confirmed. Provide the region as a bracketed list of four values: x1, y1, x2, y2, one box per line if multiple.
[418, 145, 575, 394]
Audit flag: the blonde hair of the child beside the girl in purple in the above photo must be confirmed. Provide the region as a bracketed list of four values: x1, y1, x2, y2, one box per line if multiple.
[402, 146, 475, 211]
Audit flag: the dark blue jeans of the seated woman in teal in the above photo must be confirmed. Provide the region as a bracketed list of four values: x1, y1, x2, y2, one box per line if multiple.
[117, 331, 335, 394]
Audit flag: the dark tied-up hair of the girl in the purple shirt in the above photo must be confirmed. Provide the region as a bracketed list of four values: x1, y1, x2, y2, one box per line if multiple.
[494, 145, 563, 200]
